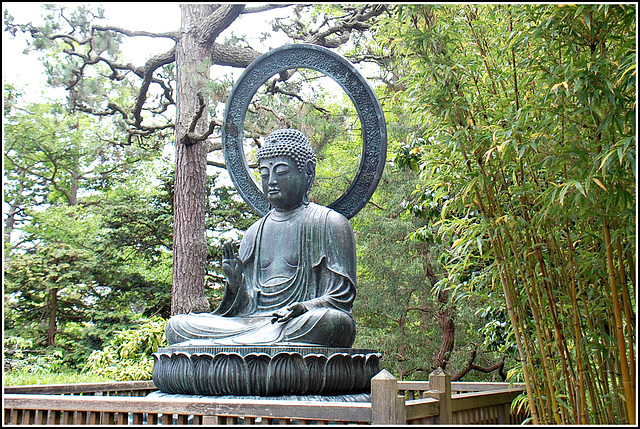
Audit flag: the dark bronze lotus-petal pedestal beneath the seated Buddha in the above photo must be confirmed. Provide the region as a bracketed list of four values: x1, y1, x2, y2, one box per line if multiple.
[153, 341, 381, 397]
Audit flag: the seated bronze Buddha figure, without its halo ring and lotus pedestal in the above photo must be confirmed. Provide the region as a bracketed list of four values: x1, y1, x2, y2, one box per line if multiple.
[166, 129, 356, 347]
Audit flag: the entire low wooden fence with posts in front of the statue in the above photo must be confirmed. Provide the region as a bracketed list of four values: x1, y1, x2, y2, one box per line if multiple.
[3, 370, 528, 425]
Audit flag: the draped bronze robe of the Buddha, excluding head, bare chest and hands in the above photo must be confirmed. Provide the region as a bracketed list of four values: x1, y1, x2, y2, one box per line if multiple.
[167, 203, 356, 347]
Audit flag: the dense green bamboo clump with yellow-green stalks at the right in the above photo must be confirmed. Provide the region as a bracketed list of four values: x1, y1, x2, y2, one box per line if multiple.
[380, 5, 636, 424]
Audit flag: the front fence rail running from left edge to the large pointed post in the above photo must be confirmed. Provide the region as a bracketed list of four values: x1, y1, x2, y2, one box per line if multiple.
[4, 394, 371, 425]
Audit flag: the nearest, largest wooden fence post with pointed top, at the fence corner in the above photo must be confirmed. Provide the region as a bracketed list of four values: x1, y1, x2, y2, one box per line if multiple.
[371, 369, 405, 425]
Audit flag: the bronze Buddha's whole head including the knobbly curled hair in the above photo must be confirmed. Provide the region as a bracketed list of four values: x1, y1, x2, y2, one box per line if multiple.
[256, 129, 316, 211]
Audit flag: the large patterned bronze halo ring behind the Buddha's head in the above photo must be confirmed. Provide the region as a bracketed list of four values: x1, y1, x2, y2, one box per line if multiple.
[222, 44, 387, 219]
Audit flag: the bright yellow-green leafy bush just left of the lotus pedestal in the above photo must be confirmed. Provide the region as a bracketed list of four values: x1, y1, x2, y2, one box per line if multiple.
[86, 316, 166, 381]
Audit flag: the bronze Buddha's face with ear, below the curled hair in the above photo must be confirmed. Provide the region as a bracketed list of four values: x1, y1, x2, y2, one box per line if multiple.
[260, 156, 312, 211]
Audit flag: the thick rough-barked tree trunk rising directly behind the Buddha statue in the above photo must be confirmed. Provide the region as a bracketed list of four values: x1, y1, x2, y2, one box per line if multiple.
[171, 4, 216, 315]
